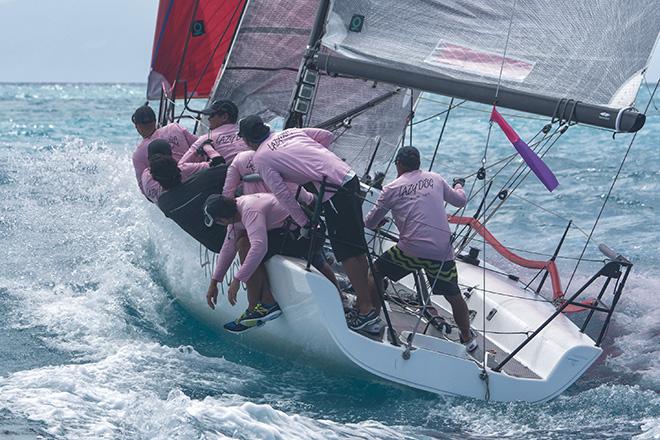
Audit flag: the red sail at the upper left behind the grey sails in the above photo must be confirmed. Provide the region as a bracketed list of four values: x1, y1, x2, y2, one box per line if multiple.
[147, 0, 246, 99]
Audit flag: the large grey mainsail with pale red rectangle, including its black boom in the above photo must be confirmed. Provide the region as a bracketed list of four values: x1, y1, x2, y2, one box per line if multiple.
[320, 0, 660, 131]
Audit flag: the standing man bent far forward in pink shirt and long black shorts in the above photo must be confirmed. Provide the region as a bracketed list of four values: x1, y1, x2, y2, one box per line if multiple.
[239, 115, 379, 329]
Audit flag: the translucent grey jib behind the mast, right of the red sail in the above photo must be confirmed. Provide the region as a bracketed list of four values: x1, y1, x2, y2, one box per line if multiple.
[213, 0, 410, 173]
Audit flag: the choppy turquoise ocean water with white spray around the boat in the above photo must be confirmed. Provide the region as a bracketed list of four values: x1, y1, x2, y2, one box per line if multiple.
[0, 84, 660, 439]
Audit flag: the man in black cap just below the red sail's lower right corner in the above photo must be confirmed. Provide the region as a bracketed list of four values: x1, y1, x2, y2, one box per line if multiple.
[181, 99, 248, 165]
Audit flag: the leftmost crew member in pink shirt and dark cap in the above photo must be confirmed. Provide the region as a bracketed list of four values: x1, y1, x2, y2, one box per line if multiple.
[131, 104, 197, 196]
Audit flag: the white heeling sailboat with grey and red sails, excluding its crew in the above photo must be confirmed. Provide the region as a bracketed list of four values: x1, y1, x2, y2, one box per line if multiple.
[142, 0, 660, 402]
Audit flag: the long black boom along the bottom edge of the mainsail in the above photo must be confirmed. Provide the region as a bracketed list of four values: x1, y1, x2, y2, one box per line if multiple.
[315, 53, 646, 132]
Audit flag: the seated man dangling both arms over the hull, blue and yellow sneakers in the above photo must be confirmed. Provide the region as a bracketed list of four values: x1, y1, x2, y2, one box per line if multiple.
[204, 193, 327, 332]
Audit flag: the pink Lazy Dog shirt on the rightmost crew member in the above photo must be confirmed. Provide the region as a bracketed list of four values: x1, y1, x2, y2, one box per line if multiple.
[364, 170, 467, 261]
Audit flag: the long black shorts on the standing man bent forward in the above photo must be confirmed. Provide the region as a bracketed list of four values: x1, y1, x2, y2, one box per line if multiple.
[323, 176, 367, 262]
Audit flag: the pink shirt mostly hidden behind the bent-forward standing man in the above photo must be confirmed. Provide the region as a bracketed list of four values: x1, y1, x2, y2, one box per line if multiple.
[222, 150, 314, 204]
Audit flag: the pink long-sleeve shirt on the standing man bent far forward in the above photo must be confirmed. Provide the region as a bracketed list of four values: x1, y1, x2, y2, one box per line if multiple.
[254, 128, 352, 226]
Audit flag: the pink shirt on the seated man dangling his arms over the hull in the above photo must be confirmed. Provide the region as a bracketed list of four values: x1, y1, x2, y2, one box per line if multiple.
[213, 193, 289, 282]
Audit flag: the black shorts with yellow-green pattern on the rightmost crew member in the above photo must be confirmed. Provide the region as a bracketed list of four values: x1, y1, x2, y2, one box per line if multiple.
[374, 245, 461, 296]
